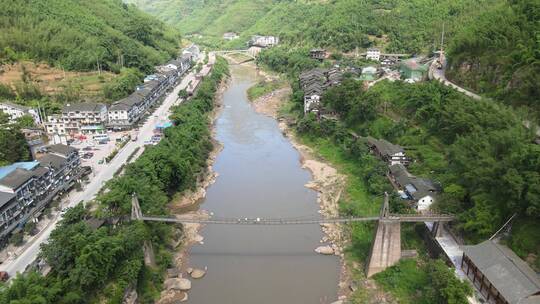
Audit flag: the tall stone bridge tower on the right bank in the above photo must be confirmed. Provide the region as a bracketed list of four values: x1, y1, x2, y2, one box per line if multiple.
[366, 192, 401, 278]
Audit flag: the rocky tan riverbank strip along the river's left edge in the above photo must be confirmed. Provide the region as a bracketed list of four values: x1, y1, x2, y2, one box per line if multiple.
[157, 63, 230, 304]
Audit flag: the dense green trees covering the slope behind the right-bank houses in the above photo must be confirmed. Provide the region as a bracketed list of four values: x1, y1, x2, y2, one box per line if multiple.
[297, 75, 540, 251]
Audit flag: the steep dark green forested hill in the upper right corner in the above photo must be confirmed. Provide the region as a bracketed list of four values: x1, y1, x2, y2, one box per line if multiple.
[449, 0, 540, 118]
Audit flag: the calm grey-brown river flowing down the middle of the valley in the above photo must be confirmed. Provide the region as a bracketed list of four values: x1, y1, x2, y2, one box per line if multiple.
[189, 65, 340, 304]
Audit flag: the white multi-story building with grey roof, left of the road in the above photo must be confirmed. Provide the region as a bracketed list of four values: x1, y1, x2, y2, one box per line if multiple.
[45, 102, 108, 136]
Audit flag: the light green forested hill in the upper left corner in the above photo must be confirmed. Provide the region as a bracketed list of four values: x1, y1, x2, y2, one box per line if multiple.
[0, 0, 180, 71]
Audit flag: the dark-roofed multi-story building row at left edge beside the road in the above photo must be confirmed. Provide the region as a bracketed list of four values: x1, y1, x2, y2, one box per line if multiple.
[0, 145, 80, 243]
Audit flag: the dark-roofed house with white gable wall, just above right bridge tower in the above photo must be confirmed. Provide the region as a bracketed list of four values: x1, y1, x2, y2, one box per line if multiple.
[388, 163, 440, 212]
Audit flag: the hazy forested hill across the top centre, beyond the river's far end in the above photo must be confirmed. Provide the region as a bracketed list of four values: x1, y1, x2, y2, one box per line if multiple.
[130, 0, 486, 52]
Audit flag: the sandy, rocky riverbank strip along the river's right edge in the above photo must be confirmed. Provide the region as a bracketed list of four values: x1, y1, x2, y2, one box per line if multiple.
[249, 73, 352, 300]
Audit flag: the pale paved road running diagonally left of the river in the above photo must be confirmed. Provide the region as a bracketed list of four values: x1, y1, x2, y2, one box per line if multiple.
[0, 55, 210, 277]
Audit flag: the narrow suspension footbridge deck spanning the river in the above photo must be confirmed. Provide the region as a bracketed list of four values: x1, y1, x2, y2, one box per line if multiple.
[140, 215, 454, 225]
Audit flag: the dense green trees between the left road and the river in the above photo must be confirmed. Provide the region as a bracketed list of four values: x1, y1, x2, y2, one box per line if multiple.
[0, 58, 227, 304]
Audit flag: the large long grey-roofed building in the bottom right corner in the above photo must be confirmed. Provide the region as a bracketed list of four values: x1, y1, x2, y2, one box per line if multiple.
[461, 240, 540, 304]
